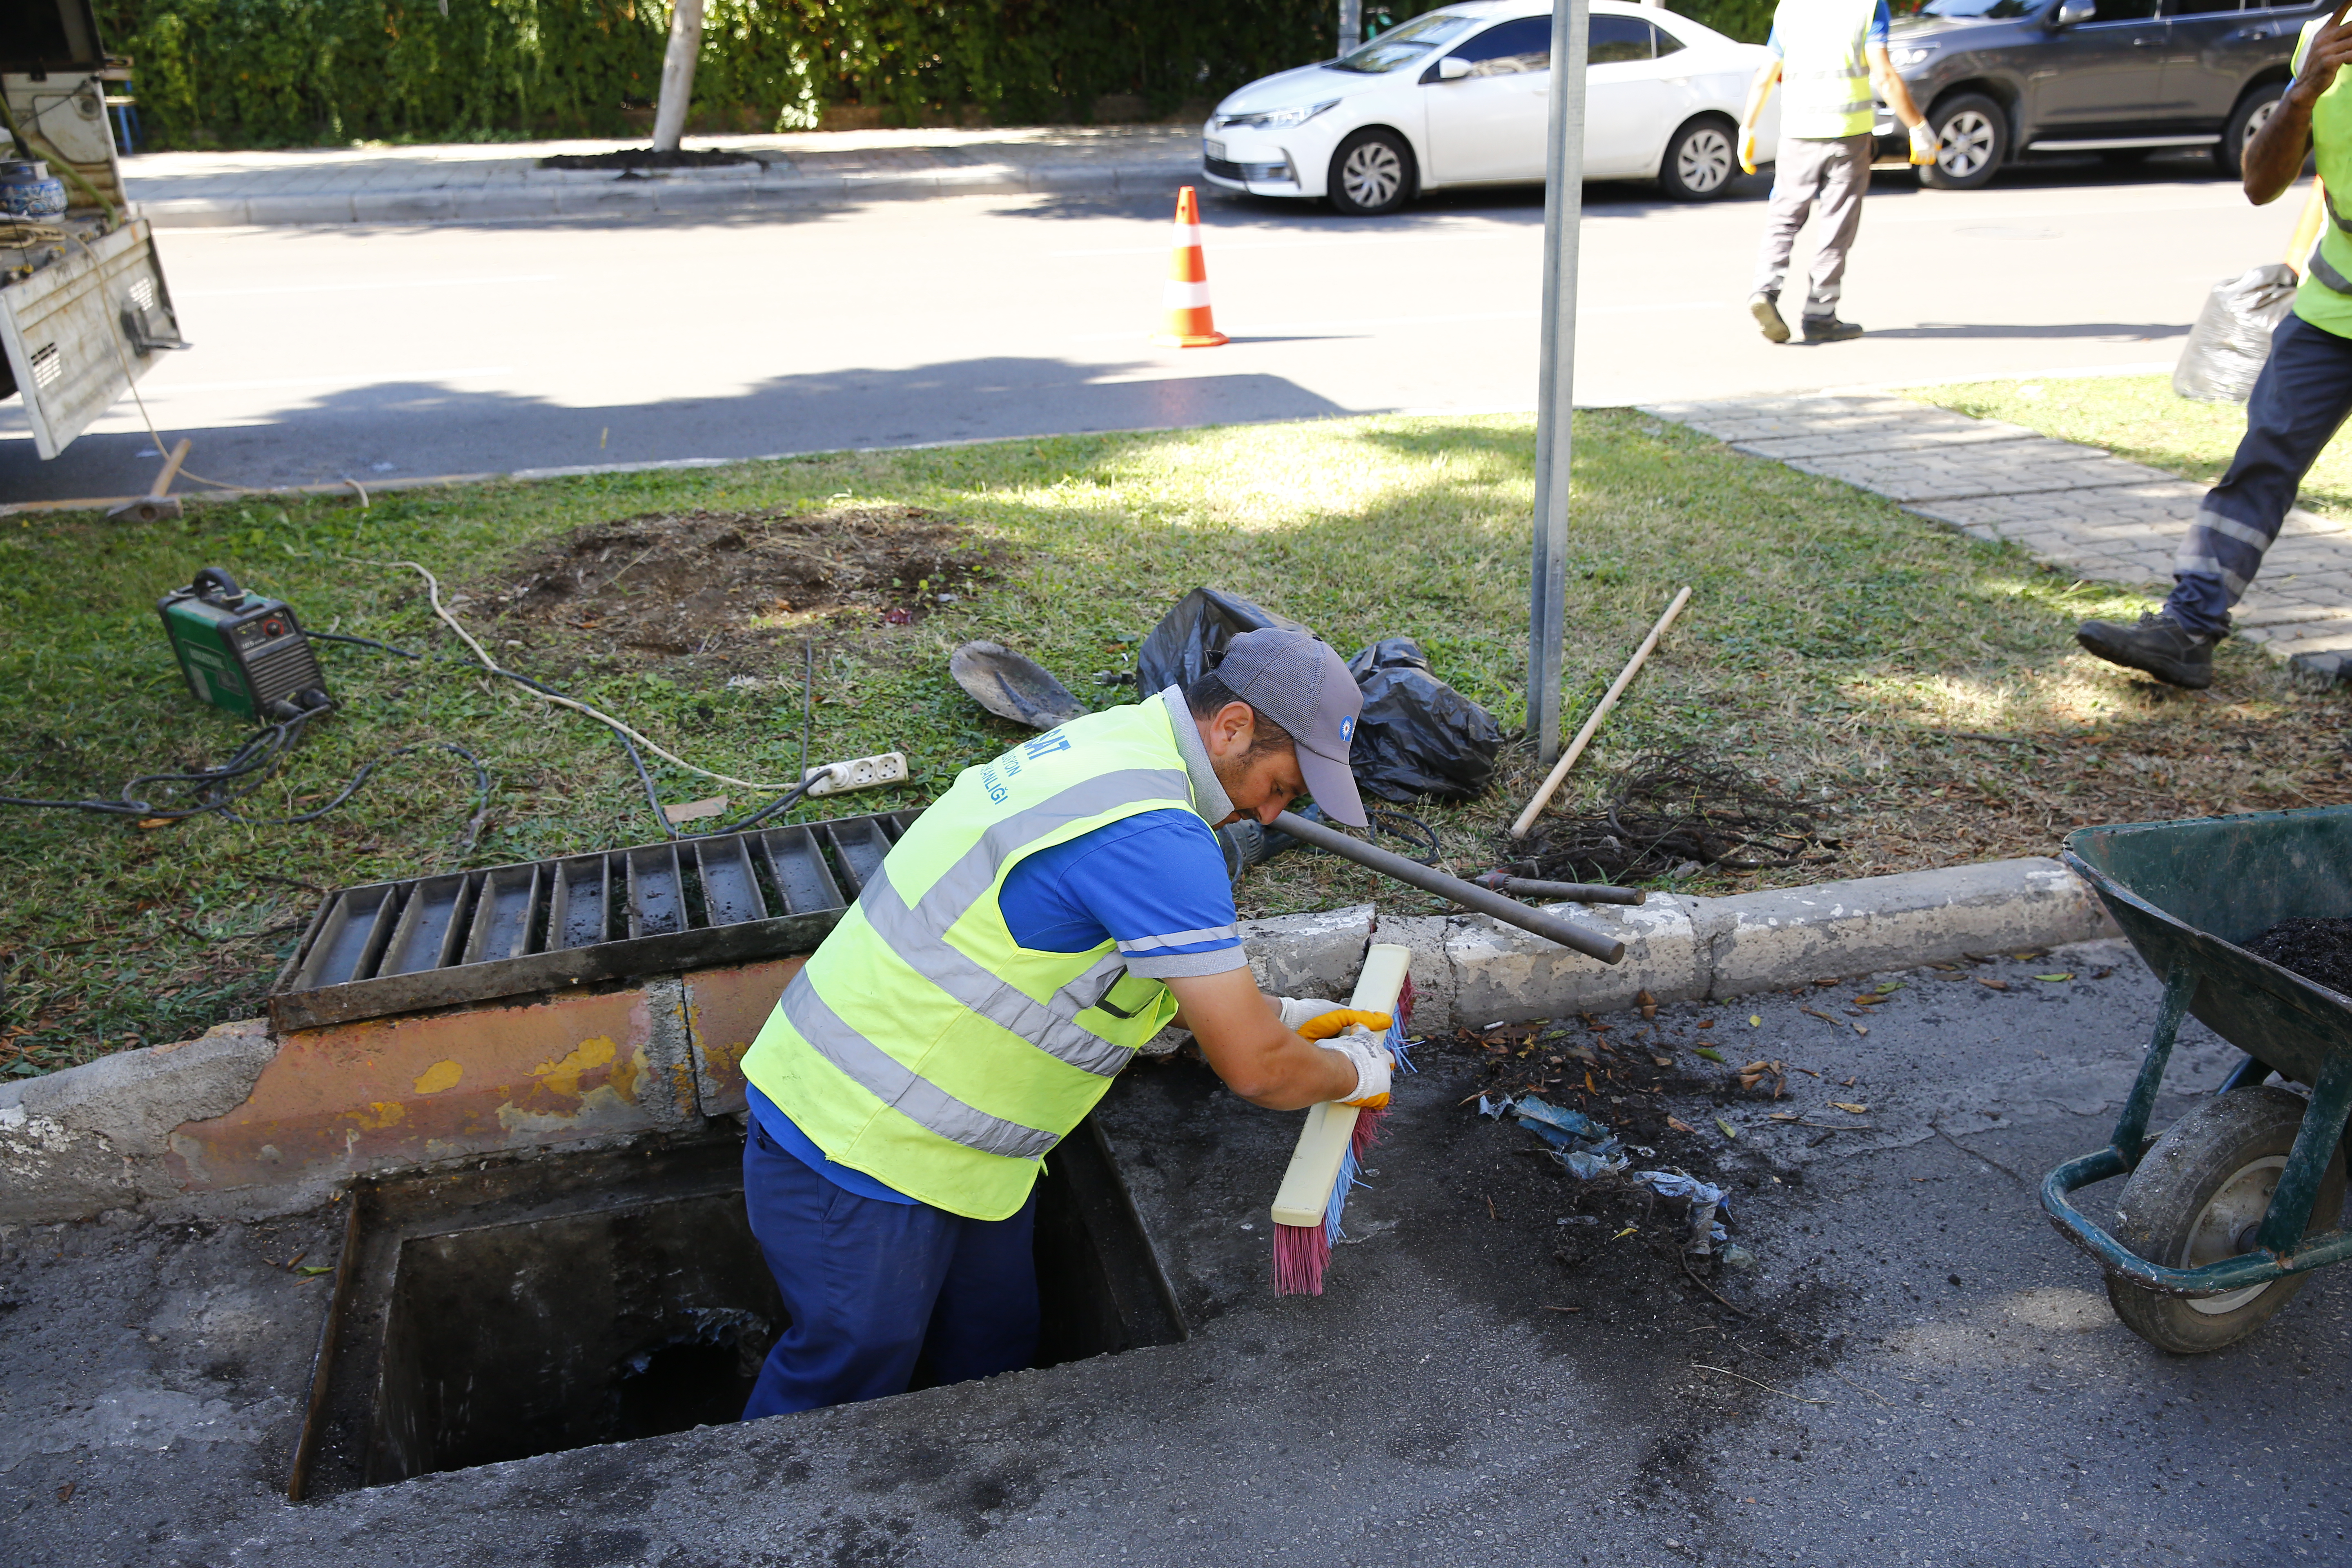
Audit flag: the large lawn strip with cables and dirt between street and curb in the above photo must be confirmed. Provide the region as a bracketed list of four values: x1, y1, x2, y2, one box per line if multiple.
[0, 411, 2343, 1072]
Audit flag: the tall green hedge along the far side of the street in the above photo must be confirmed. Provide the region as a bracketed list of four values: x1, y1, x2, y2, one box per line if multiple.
[99, 0, 1771, 148]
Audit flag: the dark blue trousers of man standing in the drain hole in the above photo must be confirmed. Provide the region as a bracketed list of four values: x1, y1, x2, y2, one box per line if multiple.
[743, 1117, 1037, 1420]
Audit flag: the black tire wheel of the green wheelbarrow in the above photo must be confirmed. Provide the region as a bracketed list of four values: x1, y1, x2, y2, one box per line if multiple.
[2107, 1086, 2345, 1356]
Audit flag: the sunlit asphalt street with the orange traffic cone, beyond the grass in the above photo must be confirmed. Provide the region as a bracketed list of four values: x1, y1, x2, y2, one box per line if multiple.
[0, 160, 2303, 501]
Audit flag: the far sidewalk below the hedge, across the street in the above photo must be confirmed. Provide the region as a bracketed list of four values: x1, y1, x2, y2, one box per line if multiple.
[122, 125, 1200, 228]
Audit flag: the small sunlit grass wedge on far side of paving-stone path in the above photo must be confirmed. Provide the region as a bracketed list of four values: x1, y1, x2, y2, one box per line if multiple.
[1905, 376, 2352, 519]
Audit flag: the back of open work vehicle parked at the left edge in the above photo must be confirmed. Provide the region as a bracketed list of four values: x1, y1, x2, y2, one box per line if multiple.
[0, 0, 188, 459]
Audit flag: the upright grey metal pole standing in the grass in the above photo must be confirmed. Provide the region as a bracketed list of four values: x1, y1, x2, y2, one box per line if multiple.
[1526, 0, 1590, 764]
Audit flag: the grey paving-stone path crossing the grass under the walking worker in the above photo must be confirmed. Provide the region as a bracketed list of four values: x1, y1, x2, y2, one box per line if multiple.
[1642, 395, 2352, 682]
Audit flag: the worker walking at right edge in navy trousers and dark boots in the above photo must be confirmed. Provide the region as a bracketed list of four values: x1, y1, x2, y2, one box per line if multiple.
[2074, 5, 2352, 691]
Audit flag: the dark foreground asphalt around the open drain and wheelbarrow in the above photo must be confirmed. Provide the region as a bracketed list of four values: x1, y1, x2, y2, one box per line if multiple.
[0, 943, 2352, 1568]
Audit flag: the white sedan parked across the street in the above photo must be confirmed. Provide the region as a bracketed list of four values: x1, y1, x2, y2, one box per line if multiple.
[1202, 0, 1780, 216]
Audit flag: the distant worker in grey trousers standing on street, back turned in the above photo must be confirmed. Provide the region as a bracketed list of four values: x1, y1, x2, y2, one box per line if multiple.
[1740, 0, 1936, 343]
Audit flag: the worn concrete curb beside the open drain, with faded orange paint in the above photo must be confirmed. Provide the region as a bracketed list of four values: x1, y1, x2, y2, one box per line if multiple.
[0, 858, 2117, 1225]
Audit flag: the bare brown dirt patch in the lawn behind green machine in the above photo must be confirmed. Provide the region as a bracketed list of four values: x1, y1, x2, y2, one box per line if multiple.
[468, 506, 1002, 661]
